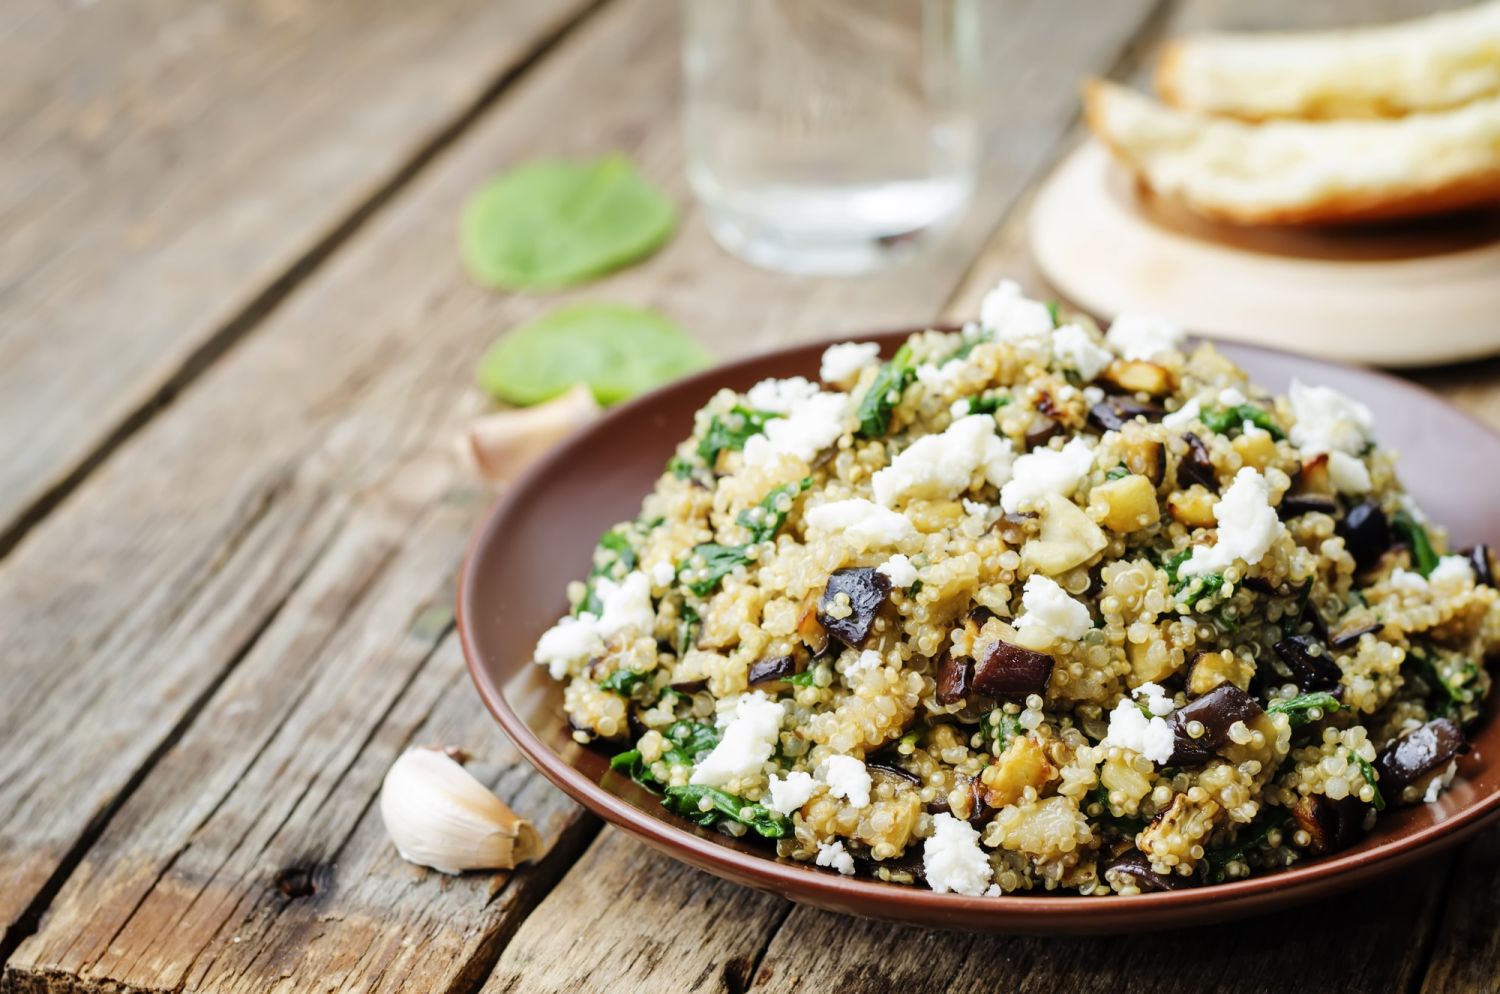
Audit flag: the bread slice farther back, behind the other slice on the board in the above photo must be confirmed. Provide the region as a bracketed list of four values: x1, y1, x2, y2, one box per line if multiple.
[1157, 0, 1500, 120]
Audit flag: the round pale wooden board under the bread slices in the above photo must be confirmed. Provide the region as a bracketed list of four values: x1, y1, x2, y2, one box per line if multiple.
[1031, 139, 1500, 366]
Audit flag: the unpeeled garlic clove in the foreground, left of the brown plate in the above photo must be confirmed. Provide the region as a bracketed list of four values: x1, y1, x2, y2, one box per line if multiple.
[380, 747, 542, 874]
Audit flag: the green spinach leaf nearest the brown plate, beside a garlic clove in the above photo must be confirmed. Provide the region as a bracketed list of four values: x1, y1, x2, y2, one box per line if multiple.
[479, 303, 713, 405]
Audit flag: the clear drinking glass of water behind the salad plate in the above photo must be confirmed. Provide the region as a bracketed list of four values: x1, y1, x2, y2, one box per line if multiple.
[683, 0, 980, 274]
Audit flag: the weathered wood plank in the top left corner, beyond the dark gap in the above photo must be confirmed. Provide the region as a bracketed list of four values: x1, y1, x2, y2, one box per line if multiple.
[0, 0, 587, 553]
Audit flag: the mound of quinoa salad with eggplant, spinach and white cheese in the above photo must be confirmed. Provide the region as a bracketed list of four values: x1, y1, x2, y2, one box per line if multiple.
[536, 282, 1500, 895]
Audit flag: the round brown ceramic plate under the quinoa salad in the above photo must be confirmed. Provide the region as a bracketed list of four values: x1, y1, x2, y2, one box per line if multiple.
[458, 331, 1500, 934]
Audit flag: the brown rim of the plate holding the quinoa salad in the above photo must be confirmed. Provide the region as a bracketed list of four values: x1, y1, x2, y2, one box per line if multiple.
[455, 322, 1500, 933]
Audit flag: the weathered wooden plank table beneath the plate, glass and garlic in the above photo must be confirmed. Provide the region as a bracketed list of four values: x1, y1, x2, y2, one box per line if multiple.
[0, 0, 1500, 993]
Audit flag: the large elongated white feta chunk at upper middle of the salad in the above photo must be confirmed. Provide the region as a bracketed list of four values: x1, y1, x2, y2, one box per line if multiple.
[870, 414, 1013, 507]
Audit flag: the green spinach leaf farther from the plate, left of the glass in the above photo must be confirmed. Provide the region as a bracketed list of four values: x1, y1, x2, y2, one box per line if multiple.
[459, 154, 677, 289]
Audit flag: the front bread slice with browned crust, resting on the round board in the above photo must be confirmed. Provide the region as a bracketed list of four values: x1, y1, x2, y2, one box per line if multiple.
[1085, 79, 1500, 225]
